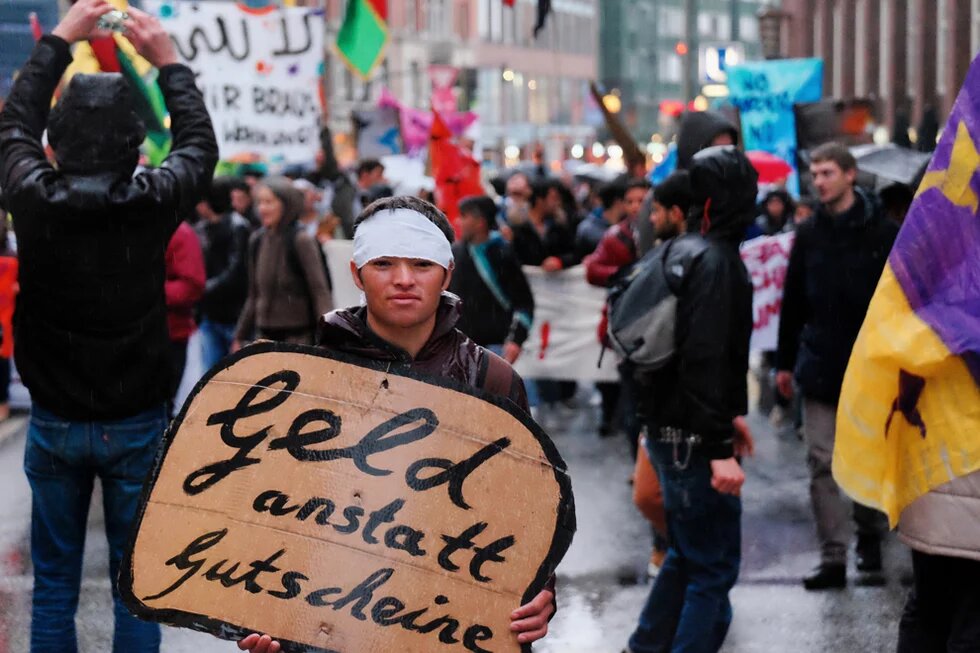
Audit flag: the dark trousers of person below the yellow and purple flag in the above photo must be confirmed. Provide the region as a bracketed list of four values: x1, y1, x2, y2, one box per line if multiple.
[898, 551, 980, 653]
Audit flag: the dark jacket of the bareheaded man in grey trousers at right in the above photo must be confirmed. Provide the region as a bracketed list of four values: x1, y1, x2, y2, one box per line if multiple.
[776, 189, 898, 404]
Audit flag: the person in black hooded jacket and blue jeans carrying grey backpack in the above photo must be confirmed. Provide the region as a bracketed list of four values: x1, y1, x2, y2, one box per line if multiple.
[628, 146, 758, 653]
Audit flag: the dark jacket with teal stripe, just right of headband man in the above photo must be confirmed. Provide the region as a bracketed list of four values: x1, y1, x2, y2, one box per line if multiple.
[449, 233, 534, 347]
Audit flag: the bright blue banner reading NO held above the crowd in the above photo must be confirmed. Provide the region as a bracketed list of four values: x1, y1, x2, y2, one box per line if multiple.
[728, 59, 823, 197]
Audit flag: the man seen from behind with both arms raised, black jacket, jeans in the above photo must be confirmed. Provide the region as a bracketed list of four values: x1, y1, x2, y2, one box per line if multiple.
[0, 0, 218, 653]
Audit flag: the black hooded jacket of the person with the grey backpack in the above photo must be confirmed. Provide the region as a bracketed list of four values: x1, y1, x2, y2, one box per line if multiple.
[638, 147, 758, 459]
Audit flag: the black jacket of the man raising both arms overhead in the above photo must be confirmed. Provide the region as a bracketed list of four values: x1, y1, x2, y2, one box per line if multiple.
[0, 36, 218, 420]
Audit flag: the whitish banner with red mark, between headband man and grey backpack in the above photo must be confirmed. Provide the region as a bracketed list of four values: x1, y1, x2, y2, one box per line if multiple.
[514, 265, 619, 381]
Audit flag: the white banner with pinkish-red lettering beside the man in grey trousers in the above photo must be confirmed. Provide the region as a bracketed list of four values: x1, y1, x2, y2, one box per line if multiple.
[741, 232, 796, 351]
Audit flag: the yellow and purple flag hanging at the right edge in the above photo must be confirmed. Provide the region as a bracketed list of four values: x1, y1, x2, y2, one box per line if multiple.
[834, 58, 980, 526]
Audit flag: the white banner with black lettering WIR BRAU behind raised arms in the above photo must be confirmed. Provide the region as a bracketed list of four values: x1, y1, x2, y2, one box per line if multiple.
[145, 0, 324, 163]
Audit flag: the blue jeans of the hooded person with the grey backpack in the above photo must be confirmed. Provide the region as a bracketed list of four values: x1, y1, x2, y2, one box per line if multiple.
[629, 442, 742, 653]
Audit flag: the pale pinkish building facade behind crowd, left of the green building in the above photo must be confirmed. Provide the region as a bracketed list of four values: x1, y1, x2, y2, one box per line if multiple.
[325, 0, 601, 163]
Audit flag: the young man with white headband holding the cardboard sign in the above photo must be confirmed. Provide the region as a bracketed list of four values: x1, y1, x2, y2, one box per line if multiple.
[238, 197, 555, 653]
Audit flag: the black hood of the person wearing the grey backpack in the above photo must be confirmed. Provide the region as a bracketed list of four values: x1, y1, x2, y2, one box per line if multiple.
[688, 145, 759, 243]
